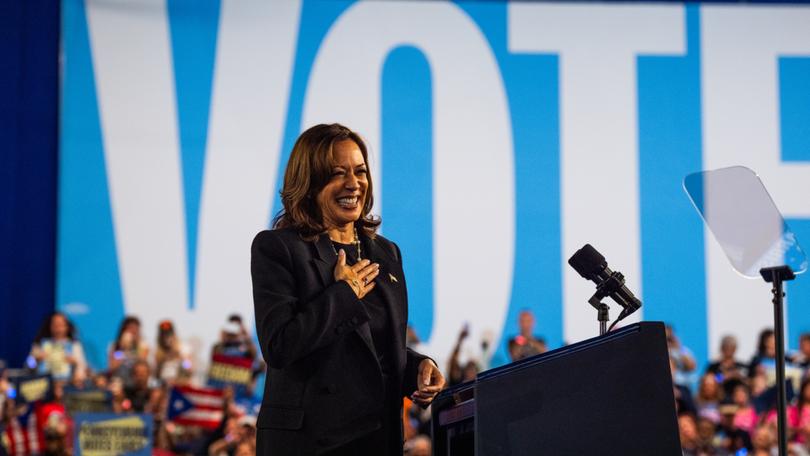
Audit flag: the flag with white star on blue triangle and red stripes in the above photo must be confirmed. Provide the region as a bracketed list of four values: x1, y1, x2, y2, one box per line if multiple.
[169, 386, 225, 429]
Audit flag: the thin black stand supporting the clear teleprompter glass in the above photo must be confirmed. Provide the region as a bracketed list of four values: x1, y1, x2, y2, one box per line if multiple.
[759, 266, 796, 456]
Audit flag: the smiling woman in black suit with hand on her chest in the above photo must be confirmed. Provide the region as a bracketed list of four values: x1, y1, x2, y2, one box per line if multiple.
[251, 124, 444, 456]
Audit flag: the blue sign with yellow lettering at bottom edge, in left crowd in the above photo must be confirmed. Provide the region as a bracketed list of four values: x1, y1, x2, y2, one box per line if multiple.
[73, 413, 153, 456]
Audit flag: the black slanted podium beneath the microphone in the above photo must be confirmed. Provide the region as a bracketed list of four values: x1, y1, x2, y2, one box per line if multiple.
[432, 322, 682, 456]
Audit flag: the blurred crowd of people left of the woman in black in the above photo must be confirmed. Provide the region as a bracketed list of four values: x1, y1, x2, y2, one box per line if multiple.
[0, 312, 264, 456]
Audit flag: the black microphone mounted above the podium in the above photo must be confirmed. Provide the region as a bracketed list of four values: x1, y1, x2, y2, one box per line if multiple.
[568, 244, 641, 322]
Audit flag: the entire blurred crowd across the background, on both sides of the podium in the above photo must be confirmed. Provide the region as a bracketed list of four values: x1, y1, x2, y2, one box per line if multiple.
[0, 310, 810, 456]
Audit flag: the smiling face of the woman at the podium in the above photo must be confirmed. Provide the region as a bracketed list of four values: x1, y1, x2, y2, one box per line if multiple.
[317, 139, 368, 228]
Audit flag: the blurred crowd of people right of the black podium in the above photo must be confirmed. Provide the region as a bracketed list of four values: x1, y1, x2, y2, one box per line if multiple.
[667, 327, 810, 456]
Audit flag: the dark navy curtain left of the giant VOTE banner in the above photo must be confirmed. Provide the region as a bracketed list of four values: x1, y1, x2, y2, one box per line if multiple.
[0, 0, 60, 365]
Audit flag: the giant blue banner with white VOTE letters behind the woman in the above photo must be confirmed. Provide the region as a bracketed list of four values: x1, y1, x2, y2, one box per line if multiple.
[57, 0, 810, 376]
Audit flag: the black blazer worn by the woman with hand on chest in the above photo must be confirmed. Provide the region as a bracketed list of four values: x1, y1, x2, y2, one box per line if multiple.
[251, 228, 425, 456]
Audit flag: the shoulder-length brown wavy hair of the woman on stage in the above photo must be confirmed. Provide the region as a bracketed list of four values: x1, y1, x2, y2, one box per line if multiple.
[273, 123, 381, 240]
